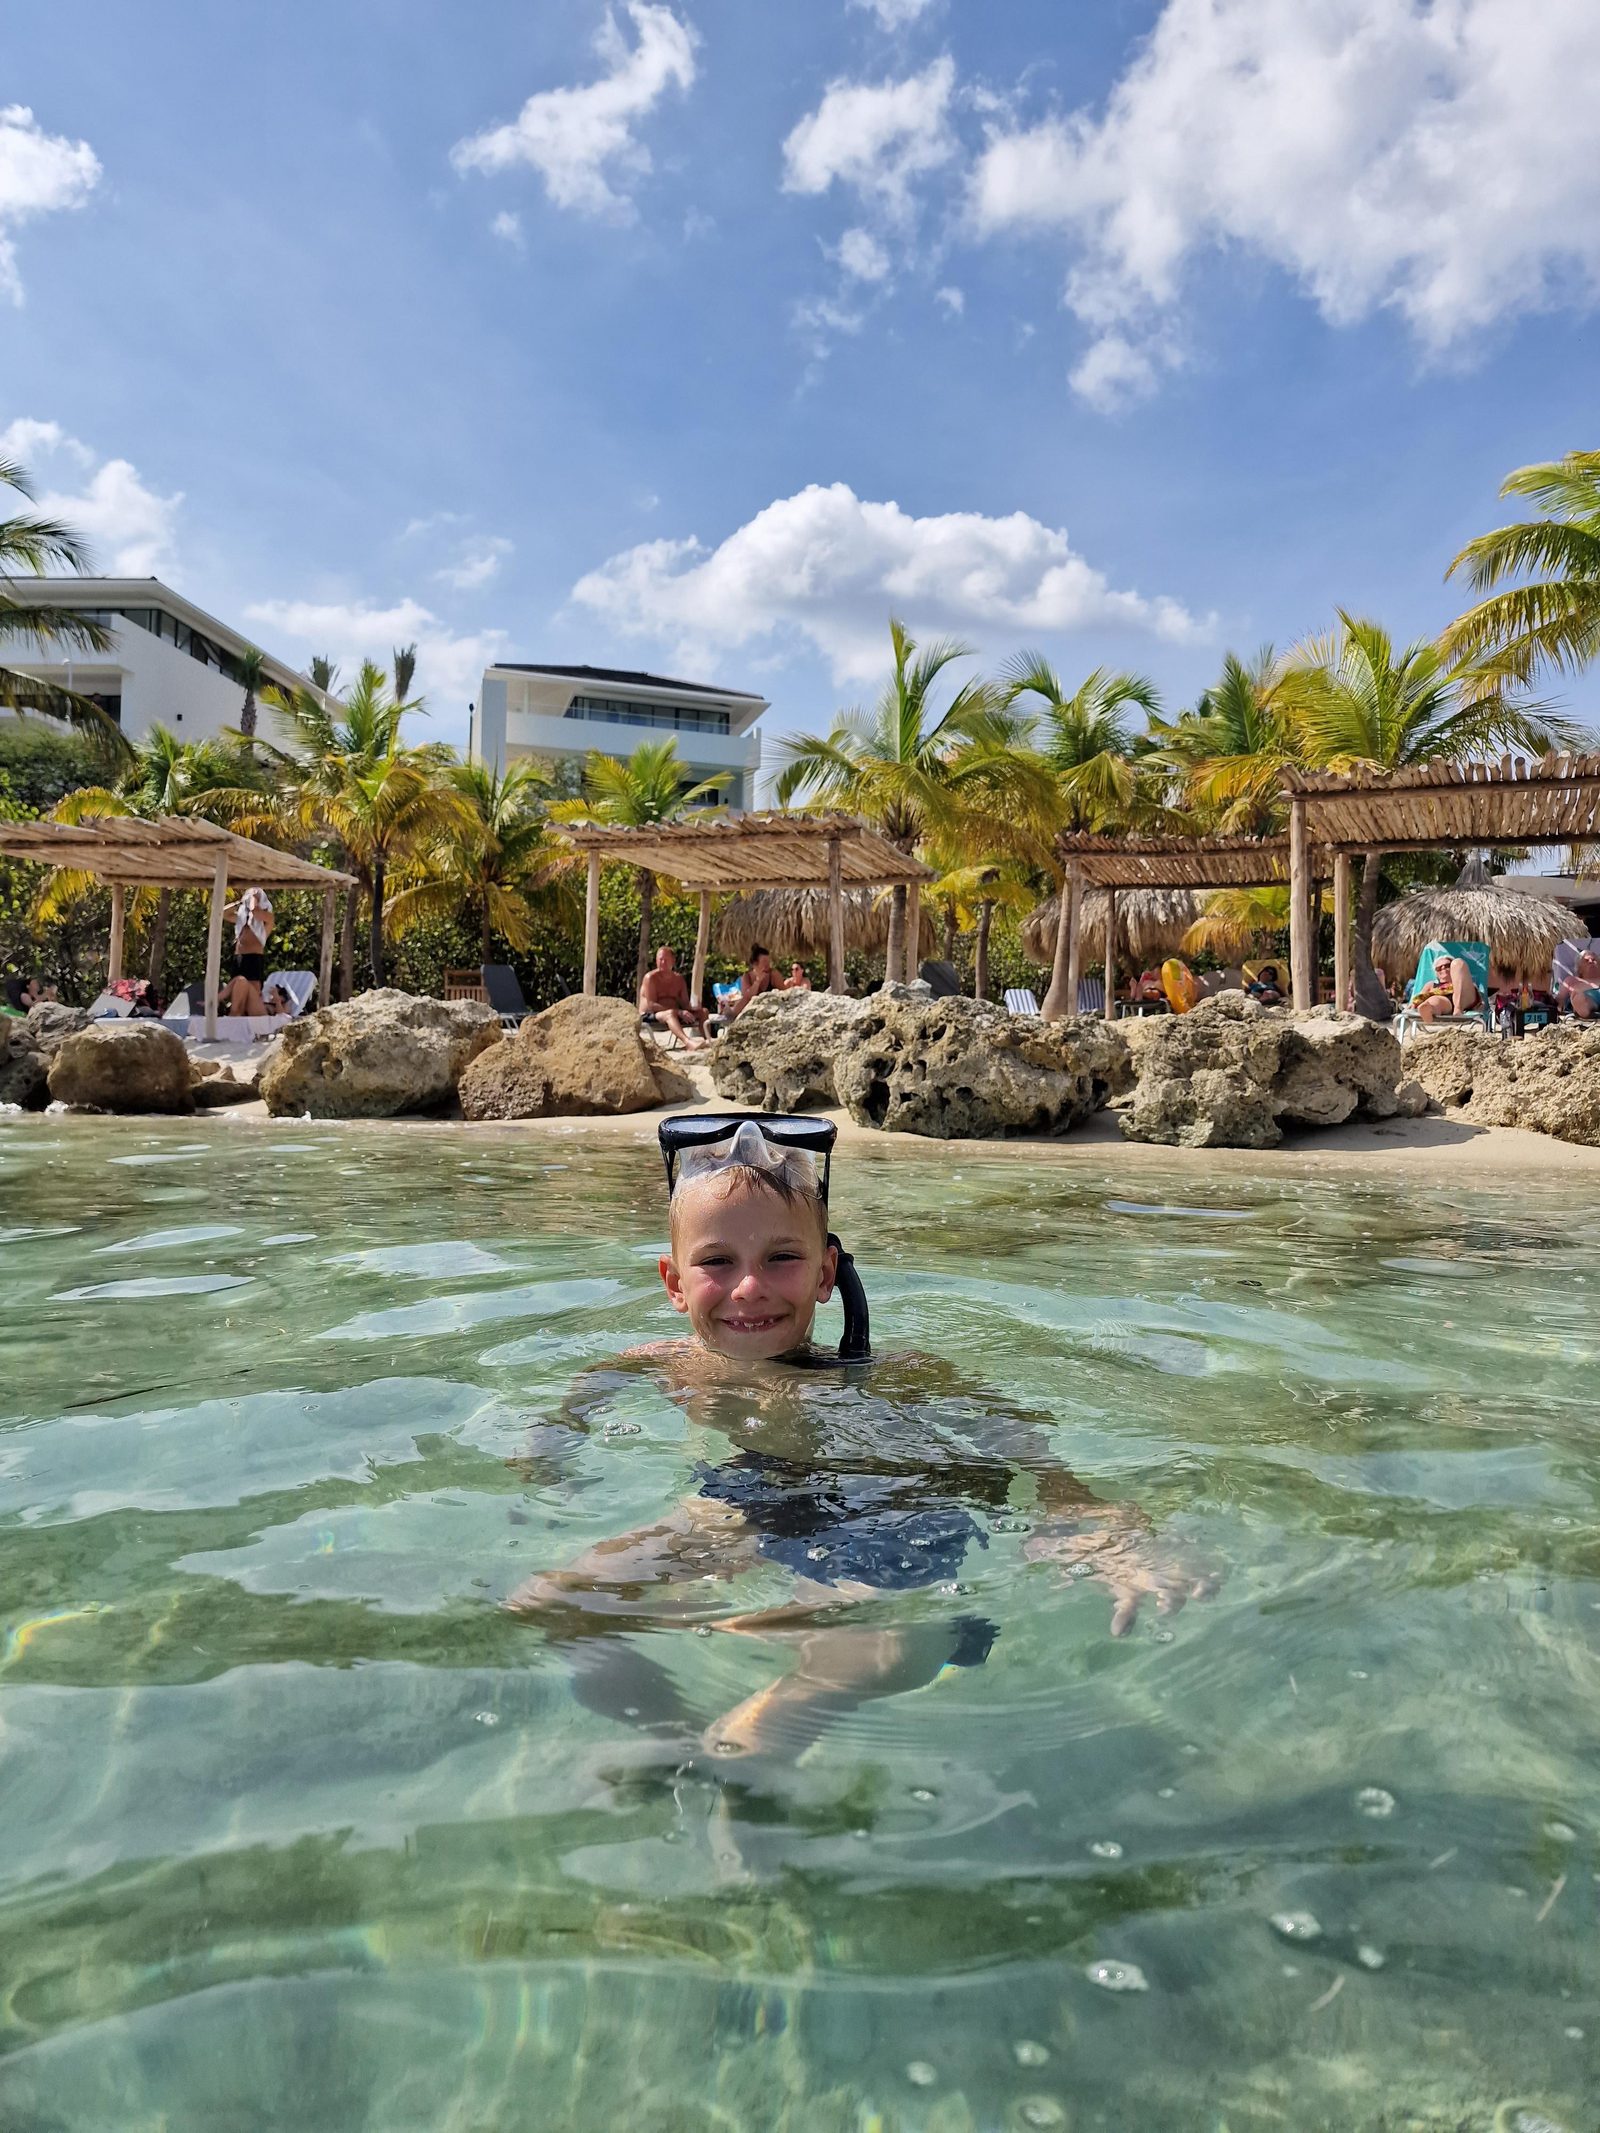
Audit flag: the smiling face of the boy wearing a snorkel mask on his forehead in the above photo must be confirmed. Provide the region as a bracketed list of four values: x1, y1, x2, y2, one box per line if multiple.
[661, 1180, 838, 1363]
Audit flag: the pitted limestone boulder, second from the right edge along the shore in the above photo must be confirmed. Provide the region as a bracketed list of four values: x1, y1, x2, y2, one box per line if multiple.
[1122, 992, 1404, 1148]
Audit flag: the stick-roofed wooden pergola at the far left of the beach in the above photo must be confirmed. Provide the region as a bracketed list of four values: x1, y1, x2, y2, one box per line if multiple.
[0, 815, 356, 1039]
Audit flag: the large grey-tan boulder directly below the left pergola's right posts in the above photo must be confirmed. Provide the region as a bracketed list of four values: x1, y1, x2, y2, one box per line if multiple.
[256, 988, 499, 1118]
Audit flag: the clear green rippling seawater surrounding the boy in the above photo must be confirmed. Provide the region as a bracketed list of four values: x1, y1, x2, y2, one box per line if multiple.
[0, 1120, 1600, 2133]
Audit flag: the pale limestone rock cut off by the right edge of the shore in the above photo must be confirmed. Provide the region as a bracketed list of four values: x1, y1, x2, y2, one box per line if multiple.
[1406, 1022, 1600, 1148]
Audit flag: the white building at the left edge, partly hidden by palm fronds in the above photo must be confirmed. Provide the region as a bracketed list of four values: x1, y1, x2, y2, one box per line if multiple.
[4, 578, 305, 744]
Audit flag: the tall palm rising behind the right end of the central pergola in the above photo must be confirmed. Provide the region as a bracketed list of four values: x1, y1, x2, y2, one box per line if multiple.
[777, 619, 1037, 981]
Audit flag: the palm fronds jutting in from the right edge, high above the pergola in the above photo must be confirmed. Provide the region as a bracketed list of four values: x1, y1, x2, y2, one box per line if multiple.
[1442, 452, 1600, 683]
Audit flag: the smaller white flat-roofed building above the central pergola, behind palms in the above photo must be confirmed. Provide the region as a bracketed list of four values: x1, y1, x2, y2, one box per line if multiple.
[471, 661, 768, 808]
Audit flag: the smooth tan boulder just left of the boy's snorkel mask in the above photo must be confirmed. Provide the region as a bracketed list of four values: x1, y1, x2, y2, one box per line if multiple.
[461, 992, 669, 1120]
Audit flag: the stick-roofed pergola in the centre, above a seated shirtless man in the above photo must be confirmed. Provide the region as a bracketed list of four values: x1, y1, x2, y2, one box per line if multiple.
[563, 813, 934, 1005]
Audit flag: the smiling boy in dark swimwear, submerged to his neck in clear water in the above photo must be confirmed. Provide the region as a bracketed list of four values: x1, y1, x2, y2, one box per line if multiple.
[510, 1120, 1205, 1755]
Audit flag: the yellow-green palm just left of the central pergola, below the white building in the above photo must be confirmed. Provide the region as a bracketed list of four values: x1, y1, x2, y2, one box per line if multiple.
[388, 761, 572, 962]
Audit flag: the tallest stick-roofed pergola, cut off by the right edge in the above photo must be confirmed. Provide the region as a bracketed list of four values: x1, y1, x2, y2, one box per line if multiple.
[1284, 755, 1600, 1007]
